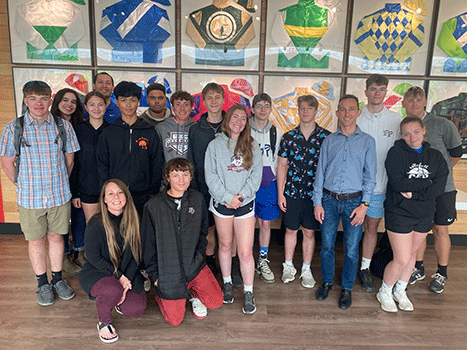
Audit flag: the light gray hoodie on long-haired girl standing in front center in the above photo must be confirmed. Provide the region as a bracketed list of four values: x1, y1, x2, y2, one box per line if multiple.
[204, 132, 263, 204]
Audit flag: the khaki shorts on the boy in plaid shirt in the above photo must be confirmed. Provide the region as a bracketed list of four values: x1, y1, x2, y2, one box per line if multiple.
[18, 201, 71, 241]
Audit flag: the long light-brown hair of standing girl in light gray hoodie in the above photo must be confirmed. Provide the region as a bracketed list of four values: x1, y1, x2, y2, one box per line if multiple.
[222, 105, 254, 170]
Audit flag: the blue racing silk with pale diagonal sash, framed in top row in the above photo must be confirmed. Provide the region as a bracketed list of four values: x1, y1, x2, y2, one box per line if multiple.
[99, 0, 172, 63]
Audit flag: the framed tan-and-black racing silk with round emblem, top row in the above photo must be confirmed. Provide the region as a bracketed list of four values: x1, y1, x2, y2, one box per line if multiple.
[180, 0, 261, 71]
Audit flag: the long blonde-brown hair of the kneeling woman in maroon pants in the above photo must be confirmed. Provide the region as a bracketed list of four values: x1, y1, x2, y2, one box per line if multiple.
[99, 179, 142, 272]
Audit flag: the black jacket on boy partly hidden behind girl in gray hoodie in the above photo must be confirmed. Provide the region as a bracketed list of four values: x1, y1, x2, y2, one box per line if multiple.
[187, 111, 225, 198]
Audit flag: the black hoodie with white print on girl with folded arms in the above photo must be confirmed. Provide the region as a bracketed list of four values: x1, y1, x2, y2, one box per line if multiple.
[384, 140, 449, 218]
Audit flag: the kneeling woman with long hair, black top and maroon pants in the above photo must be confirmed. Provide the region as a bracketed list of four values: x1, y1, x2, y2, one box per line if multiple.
[79, 179, 146, 343]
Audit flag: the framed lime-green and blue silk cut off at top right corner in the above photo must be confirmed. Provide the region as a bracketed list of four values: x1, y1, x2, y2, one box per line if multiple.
[431, 0, 467, 77]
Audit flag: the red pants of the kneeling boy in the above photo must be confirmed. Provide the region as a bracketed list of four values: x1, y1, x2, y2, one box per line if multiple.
[156, 266, 224, 326]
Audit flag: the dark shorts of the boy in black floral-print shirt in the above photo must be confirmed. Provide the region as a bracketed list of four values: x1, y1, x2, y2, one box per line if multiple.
[282, 196, 319, 231]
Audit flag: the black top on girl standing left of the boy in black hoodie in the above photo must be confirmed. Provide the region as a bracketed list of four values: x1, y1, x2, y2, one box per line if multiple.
[70, 119, 110, 198]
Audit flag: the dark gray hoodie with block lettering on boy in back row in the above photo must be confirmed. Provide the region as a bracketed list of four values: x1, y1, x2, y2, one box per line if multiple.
[156, 116, 195, 162]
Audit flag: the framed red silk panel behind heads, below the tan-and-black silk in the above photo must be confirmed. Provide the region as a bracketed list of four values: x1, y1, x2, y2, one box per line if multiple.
[182, 73, 259, 121]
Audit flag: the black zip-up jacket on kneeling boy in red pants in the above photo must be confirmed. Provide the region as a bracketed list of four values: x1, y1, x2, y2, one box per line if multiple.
[141, 189, 208, 300]
